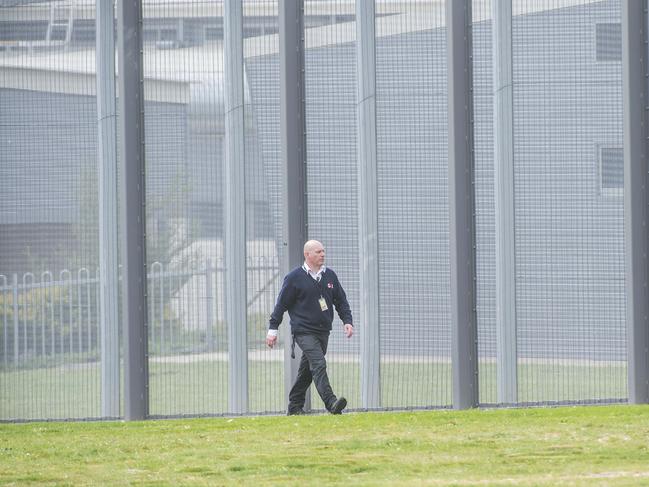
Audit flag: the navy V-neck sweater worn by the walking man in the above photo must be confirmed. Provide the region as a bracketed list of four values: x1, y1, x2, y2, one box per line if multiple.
[268, 267, 353, 334]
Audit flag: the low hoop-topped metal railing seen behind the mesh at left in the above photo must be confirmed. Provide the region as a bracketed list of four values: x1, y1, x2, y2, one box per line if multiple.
[0, 257, 279, 368]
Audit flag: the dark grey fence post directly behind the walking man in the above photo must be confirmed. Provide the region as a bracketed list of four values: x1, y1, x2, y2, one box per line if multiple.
[279, 0, 311, 409]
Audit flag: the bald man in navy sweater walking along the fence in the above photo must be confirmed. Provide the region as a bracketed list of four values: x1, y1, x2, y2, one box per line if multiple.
[266, 240, 354, 415]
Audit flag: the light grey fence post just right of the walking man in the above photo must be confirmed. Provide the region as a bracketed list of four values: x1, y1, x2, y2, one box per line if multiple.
[356, 0, 381, 408]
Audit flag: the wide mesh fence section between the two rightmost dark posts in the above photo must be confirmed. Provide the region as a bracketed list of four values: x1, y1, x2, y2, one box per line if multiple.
[473, 0, 626, 404]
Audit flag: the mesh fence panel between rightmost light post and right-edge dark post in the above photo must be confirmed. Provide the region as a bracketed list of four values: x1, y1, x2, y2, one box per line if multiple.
[494, 1, 626, 403]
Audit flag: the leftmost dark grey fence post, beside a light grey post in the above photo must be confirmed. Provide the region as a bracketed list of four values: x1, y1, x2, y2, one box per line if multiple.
[117, 0, 149, 420]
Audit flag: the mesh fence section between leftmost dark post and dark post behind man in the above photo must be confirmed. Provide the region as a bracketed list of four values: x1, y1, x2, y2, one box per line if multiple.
[144, 1, 283, 415]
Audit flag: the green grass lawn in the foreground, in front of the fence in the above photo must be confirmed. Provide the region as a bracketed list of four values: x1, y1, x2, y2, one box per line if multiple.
[0, 405, 649, 486]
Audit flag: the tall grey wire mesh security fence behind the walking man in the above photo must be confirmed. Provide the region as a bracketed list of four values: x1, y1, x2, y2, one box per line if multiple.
[0, 0, 646, 420]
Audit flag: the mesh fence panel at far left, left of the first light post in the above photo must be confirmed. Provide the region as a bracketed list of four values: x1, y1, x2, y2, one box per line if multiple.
[0, 2, 101, 419]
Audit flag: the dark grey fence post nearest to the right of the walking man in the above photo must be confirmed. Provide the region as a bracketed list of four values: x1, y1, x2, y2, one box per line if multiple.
[446, 0, 478, 409]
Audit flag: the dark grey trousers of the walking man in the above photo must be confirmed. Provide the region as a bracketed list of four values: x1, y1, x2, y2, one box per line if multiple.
[288, 333, 336, 411]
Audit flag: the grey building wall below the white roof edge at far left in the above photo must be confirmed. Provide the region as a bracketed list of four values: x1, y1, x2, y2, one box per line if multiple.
[0, 89, 97, 225]
